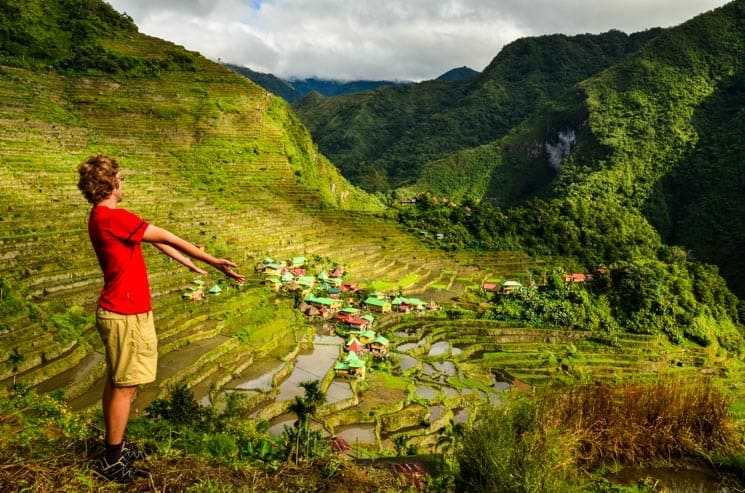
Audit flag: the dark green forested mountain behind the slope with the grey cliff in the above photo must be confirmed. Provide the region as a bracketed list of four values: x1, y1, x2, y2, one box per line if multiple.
[293, 30, 659, 191]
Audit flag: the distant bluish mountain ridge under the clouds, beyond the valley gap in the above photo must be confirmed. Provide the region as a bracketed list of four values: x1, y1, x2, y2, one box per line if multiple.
[225, 64, 408, 103]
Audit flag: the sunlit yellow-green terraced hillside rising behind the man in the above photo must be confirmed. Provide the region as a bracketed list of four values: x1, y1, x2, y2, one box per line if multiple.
[0, 28, 531, 406]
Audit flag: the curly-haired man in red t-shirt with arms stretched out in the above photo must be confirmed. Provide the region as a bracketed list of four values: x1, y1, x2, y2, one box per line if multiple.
[78, 154, 245, 481]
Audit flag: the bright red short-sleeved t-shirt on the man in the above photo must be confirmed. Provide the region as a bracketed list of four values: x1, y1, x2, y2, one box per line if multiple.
[88, 206, 152, 315]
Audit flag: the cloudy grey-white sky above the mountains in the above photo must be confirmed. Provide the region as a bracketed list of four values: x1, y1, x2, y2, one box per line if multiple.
[108, 0, 727, 81]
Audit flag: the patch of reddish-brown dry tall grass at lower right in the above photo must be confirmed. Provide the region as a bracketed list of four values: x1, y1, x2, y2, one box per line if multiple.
[544, 379, 738, 468]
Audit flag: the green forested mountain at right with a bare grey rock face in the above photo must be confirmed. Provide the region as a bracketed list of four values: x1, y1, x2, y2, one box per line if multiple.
[416, 0, 745, 296]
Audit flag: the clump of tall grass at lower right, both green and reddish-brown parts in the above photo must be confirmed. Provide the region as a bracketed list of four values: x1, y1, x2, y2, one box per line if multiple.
[456, 378, 742, 492]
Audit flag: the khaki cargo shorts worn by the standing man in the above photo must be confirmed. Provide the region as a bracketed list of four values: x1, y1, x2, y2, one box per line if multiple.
[96, 307, 158, 387]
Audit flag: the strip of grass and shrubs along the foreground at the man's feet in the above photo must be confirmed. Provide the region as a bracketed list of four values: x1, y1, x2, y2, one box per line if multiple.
[0, 372, 745, 492]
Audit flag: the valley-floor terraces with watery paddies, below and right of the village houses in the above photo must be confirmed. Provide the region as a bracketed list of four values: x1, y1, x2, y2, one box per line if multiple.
[294, 312, 742, 456]
